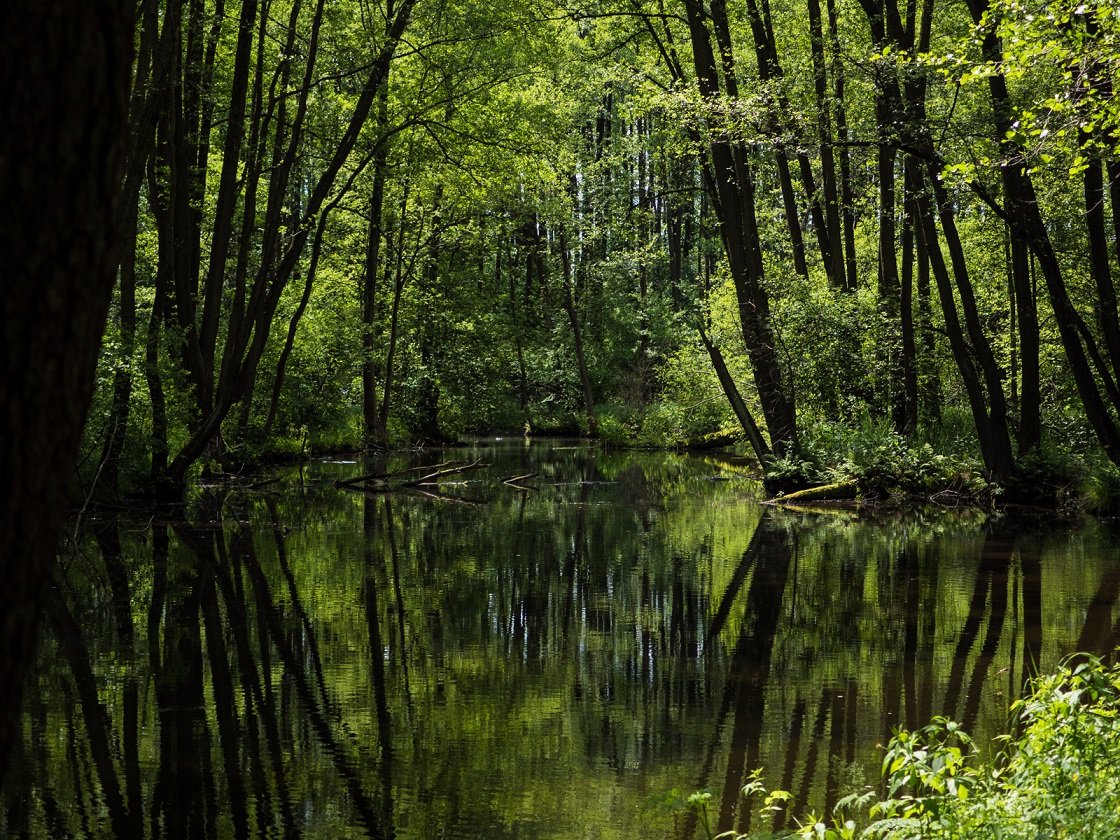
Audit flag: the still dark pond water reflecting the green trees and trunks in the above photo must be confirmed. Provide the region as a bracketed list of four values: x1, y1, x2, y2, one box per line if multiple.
[0, 441, 1120, 840]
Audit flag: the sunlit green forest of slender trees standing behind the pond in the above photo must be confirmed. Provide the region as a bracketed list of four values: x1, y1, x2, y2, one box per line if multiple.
[89, 0, 1120, 496]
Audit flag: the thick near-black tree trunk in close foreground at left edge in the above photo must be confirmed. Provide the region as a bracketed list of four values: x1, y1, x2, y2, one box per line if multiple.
[0, 0, 136, 778]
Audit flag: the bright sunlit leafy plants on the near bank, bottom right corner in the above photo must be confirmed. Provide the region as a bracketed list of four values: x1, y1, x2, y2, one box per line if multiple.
[658, 655, 1120, 840]
